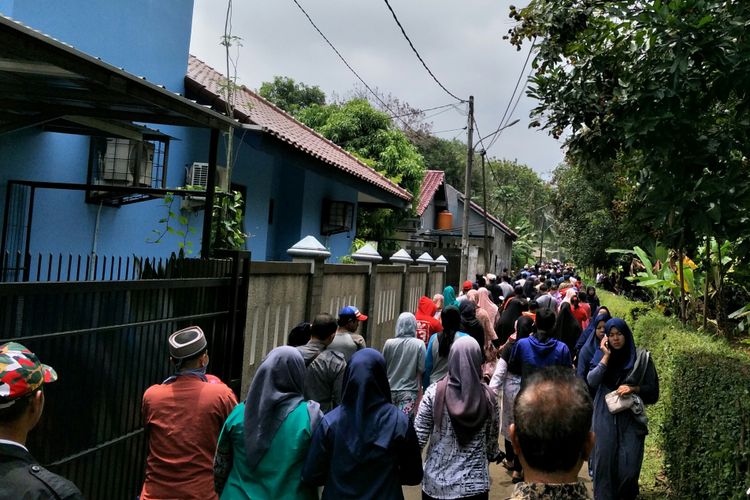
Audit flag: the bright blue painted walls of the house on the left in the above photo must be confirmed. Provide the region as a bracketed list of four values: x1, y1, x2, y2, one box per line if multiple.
[0, 0, 368, 261]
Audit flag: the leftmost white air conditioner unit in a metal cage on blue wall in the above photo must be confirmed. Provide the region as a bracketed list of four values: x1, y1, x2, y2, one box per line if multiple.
[98, 138, 154, 187]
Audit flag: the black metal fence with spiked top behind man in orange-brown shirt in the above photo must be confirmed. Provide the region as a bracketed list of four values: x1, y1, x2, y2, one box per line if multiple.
[0, 255, 249, 499]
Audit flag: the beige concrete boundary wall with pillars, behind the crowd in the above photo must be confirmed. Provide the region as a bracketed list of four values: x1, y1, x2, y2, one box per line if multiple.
[241, 256, 445, 388]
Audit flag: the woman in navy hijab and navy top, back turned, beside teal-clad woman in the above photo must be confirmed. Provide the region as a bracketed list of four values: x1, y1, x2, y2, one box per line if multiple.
[302, 348, 422, 500]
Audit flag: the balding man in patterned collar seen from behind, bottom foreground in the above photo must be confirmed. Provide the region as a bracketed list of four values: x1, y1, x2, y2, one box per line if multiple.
[509, 366, 594, 500]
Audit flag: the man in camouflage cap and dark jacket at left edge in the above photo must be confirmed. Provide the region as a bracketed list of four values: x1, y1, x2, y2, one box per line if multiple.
[0, 342, 83, 499]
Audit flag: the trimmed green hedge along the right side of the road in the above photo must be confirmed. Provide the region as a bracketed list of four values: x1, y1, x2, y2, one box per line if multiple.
[602, 294, 750, 499]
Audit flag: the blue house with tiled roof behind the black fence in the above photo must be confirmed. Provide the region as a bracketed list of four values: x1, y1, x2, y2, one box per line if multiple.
[0, 0, 411, 270]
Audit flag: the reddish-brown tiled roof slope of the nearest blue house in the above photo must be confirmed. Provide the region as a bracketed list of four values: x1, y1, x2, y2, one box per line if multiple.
[185, 55, 412, 201]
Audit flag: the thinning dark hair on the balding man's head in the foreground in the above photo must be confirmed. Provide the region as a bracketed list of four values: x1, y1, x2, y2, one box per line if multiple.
[513, 366, 594, 472]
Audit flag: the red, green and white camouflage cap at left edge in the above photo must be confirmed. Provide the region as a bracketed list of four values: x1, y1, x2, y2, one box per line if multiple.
[0, 342, 57, 409]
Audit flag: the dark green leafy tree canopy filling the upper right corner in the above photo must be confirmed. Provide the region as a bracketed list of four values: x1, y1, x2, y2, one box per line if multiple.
[509, 0, 750, 248]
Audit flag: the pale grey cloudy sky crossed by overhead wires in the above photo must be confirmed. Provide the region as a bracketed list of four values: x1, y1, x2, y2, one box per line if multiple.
[191, 0, 563, 178]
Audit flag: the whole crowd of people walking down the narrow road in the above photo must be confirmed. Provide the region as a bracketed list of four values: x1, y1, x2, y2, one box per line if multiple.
[0, 264, 659, 500]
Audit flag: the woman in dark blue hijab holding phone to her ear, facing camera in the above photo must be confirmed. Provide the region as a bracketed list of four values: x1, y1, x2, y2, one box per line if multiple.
[587, 318, 659, 500]
